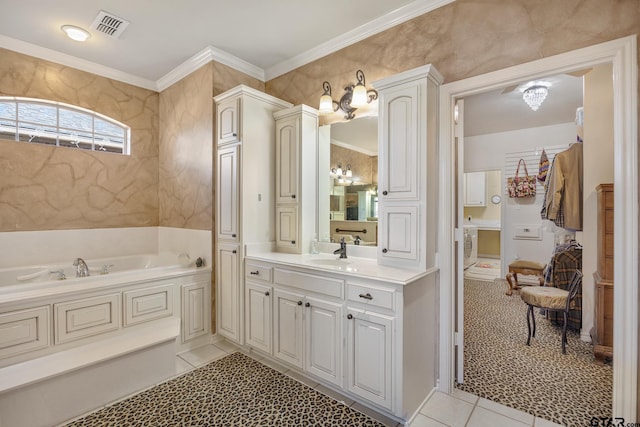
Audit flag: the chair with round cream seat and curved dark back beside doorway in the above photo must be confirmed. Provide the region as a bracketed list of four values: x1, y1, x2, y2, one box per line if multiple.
[520, 270, 582, 353]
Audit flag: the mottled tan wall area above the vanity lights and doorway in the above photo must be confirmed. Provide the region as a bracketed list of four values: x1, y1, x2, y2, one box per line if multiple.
[266, 0, 640, 124]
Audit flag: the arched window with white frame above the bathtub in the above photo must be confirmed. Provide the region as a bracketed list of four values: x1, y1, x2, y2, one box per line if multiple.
[0, 96, 131, 155]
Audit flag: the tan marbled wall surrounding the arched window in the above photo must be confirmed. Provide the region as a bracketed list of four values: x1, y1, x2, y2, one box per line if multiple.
[0, 49, 158, 231]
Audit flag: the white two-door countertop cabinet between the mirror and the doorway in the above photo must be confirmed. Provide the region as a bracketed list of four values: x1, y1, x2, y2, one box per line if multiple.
[373, 65, 443, 269]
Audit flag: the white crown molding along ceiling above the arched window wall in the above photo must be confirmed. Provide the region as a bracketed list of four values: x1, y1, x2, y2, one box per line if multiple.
[0, 35, 158, 91]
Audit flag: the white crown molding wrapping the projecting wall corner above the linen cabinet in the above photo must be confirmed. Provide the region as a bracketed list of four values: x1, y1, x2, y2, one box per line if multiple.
[156, 46, 264, 92]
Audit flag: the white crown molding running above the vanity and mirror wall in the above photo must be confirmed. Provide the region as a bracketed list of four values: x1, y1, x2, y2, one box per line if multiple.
[265, 0, 455, 80]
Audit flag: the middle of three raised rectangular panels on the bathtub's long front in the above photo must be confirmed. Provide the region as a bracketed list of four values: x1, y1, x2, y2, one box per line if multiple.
[53, 294, 120, 344]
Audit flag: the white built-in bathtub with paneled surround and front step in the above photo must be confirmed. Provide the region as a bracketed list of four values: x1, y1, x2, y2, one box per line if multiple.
[0, 252, 211, 426]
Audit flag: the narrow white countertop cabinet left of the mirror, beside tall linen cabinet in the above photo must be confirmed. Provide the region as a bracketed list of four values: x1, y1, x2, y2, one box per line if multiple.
[273, 105, 318, 253]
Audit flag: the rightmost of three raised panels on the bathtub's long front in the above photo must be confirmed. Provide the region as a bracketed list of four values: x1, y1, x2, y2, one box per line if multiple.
[123, 285, 173, 326]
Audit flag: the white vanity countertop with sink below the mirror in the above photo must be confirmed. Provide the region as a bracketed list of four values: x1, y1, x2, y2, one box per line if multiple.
[246, 252, 437, 285]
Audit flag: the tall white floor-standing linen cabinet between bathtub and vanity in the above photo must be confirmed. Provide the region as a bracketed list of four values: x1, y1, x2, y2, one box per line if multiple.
[214, 85, 291, 344]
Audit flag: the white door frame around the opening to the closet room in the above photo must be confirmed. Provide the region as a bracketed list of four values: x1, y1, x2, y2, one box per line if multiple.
[438, 35, 639, 420]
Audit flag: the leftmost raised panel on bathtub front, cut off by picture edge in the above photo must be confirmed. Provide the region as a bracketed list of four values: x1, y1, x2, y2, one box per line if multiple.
[0, 306, 50, 357]
